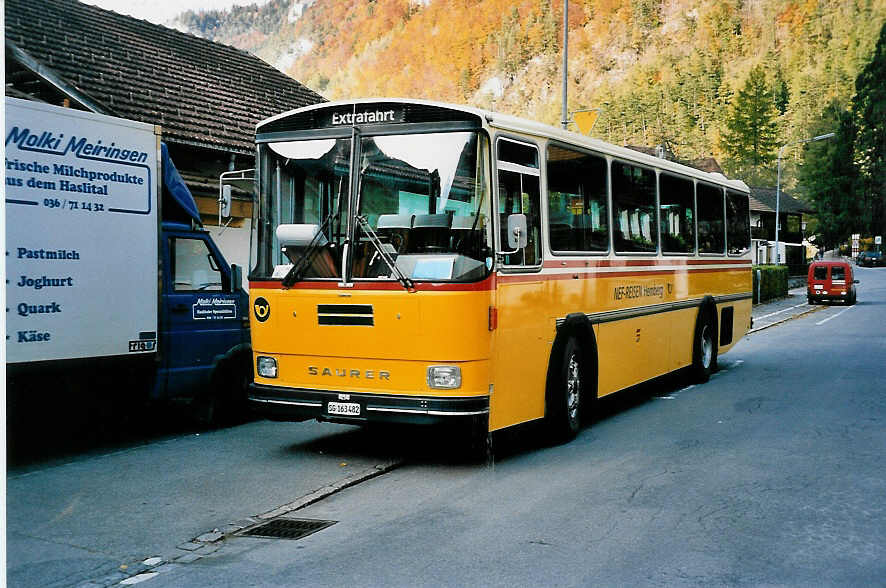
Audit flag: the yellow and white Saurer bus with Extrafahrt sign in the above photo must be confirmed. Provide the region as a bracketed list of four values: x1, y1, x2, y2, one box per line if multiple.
[249, 99, 752, 446]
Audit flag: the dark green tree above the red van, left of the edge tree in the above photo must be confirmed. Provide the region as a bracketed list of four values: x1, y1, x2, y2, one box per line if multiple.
[799, 102, 862, 247]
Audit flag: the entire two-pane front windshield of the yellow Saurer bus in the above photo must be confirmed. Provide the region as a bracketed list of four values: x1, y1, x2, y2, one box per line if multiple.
[251, 131, 492, 283]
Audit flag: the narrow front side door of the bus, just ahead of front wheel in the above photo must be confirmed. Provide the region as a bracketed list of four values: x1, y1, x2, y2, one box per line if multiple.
[489, 138, 553, 430]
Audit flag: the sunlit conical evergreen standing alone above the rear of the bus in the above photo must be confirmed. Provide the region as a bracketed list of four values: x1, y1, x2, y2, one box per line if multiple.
[721, 65, 778, 175]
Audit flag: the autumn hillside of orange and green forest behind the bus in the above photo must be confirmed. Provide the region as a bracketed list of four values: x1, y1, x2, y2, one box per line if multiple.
[179, 0, 886, 180]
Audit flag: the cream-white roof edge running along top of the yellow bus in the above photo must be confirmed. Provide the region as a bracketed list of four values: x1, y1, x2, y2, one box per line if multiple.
[256, 98, 750, 193]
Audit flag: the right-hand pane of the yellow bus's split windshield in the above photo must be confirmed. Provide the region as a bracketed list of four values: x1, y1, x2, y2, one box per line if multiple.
[351, 132, 492, 281]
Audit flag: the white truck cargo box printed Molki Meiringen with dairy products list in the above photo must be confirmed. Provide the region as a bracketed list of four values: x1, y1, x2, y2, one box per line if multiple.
[5, 98, 160, 363]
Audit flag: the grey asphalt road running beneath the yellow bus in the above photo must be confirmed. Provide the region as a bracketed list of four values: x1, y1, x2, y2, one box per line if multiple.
[7, 268, 886, 586]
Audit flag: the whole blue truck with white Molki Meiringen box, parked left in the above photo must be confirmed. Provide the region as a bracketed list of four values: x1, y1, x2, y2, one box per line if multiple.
[5, 98, 252, 434]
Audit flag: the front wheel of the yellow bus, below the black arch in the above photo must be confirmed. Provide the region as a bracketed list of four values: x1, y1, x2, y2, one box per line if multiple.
[545, 337, 589, 443]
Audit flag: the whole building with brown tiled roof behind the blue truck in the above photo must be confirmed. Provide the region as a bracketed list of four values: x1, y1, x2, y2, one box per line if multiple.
[4, 0, 325, 263]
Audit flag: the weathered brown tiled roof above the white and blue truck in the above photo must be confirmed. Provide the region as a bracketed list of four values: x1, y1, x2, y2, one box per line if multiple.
[4, 0, 325, 153]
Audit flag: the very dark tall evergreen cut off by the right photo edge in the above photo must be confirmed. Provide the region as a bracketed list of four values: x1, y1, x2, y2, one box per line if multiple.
[852, 25, 886, 236]
